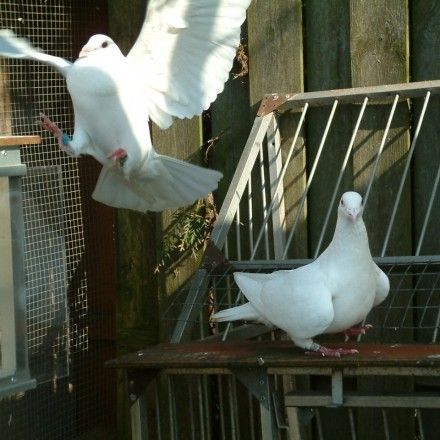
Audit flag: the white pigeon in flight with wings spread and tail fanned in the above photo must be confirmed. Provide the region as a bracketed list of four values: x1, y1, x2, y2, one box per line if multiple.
[0, 0, 251, 212]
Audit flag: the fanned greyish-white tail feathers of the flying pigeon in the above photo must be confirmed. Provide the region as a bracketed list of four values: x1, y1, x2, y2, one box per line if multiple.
[92, 155, 222, 212]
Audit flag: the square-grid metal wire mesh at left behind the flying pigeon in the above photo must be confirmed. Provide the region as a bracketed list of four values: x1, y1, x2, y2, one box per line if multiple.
[0, 0, 116, 440]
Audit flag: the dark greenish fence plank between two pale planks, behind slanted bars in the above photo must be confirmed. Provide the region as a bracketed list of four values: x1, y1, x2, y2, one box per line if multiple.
[305, 0, 353, 440]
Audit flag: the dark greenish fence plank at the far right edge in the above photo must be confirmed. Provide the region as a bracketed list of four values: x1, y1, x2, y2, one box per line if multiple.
[410, 0, 440, 439]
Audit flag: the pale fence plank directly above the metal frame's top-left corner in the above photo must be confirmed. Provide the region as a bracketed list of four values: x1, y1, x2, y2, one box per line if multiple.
[248, 0, 307, 258]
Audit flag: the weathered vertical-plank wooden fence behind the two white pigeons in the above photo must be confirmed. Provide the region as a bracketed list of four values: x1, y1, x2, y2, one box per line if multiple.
[109, 0, 440, 439]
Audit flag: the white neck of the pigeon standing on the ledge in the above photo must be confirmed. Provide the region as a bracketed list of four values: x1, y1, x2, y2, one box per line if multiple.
[329, 218, 371, 258]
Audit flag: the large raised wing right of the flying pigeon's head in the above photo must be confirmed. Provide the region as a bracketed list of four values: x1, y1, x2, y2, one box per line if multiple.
[127, 0, 251, 128]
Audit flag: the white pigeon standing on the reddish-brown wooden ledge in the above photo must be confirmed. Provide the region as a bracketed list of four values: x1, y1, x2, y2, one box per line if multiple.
[213, 191, 390, 356]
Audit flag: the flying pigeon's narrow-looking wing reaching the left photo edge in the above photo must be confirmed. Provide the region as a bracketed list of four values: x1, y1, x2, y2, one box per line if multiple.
[0, 29, 71, 74]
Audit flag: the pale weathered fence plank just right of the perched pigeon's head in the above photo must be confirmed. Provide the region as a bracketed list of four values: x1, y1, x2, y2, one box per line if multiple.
[350, 0, 414, 440]
